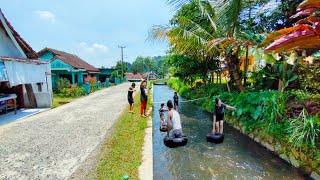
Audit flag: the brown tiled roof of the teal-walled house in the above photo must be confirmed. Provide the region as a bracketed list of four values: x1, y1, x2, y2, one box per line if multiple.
[38, 48, 99, 73]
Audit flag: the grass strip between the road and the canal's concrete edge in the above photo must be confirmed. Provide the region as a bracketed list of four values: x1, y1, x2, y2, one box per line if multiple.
[92, 95, 151, 179]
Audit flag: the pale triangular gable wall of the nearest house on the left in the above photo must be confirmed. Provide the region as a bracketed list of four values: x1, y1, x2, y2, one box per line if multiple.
[0, 28, 23, 58]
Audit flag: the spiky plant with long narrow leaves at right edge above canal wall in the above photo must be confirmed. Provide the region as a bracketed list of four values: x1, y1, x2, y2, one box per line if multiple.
[287, 110, 320, 148]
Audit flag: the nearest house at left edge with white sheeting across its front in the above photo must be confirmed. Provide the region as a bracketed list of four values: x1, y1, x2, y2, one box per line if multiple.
[0, 9, 52, 108]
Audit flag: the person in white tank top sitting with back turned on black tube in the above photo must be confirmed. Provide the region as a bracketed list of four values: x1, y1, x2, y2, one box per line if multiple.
[167, 100, 183, 138]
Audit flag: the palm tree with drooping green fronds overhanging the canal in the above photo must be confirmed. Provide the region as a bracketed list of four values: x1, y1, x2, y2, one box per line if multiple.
[150, 0, 266, 92]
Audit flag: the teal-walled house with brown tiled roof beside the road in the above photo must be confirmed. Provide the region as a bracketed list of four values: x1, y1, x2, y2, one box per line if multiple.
[38, 48, 100, 87]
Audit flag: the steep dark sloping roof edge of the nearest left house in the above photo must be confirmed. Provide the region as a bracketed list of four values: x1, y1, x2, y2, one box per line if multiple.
[0, 9, 38, 59]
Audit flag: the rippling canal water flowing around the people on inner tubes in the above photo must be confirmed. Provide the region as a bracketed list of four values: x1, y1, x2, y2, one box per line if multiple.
[153, 86, 305, 180]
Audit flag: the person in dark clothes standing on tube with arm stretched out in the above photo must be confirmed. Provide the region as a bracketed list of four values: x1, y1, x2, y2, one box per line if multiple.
[212, 98, 236, 134]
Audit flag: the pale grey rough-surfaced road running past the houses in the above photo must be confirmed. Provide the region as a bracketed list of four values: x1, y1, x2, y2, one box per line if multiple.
[0, 83, 130, 179]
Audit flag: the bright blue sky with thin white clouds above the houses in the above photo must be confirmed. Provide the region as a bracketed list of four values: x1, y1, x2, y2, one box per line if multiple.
[0, 0, 175, 67]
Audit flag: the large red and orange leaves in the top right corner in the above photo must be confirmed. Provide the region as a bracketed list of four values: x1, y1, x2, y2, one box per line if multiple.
[261, 0, 320, 53]
